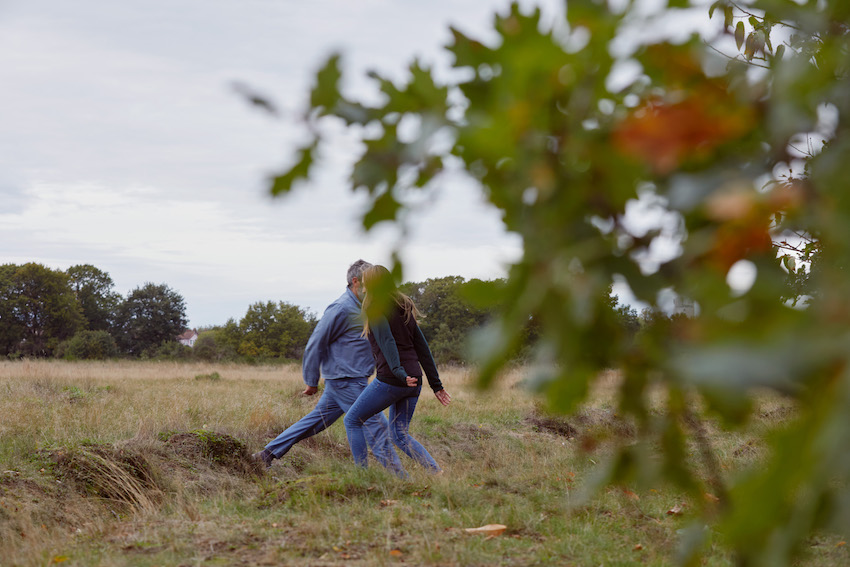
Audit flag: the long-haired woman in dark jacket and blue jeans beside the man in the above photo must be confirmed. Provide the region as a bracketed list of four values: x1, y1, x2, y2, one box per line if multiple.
[344, 266, 452, 473]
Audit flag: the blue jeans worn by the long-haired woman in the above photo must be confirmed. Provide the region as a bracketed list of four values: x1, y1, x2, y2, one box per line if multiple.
[343, 380, 440, 478]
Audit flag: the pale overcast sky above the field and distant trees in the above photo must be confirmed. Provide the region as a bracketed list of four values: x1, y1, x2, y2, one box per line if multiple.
[0, 0, 716, 327]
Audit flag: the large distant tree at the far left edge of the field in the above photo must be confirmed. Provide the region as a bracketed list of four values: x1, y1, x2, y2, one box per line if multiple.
[0, 263, 84, 356]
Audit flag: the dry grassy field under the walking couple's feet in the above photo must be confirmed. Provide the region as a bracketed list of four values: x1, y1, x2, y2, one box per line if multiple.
[0, 361, 850, 566]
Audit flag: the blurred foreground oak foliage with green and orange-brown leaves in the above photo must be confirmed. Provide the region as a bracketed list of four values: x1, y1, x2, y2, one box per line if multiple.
[264, 0, 850, 564]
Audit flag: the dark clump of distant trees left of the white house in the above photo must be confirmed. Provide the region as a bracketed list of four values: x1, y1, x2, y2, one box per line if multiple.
[0, 262, 187, 358]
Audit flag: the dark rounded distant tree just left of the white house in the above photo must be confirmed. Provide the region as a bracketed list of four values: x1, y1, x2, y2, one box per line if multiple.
[116, 283, 187, 356]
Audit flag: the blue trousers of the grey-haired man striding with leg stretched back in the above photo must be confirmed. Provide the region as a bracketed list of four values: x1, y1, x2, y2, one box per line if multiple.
[266, 378, 405, 476]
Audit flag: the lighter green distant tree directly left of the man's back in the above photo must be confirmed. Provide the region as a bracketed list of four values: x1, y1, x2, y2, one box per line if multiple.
[238, 301, 316, 359]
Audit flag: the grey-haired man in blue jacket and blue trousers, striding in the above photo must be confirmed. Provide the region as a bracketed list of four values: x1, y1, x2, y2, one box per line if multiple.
[253, 260, 406, 476]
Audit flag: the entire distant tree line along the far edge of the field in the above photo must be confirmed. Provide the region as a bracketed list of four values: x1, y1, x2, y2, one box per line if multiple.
[0, 263, 666, 364]
